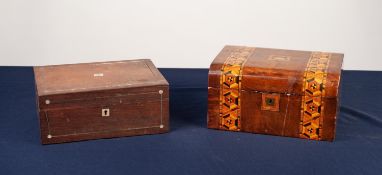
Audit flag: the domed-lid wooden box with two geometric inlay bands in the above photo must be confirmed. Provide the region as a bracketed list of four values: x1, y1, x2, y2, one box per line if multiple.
[208, 46, 343, 141]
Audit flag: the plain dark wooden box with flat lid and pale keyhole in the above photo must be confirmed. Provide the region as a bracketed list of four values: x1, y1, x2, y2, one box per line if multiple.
[34, 59, 169, 144]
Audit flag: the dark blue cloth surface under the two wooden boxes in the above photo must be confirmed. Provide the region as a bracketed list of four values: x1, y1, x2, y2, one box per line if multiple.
[0, 67, 382, 175]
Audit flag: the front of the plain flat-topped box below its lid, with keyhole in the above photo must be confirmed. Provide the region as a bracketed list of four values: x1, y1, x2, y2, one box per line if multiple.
[40, 88, 169, 144]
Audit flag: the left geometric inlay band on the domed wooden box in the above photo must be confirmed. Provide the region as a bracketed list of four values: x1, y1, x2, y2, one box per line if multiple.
[220, 47, 254, 131]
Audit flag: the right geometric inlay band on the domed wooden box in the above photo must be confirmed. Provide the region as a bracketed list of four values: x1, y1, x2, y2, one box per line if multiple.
[300, 52, 331, 140]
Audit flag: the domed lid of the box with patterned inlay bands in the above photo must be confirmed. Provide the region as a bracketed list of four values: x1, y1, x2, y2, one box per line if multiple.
[209, 46, 343, 97]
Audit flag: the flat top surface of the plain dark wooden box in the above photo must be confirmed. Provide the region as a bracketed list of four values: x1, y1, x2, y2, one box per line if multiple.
[34, 59, 168, 96]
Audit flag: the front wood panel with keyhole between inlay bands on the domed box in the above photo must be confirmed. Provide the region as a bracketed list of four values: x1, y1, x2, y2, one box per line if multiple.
[241, 91, 301, 137]
